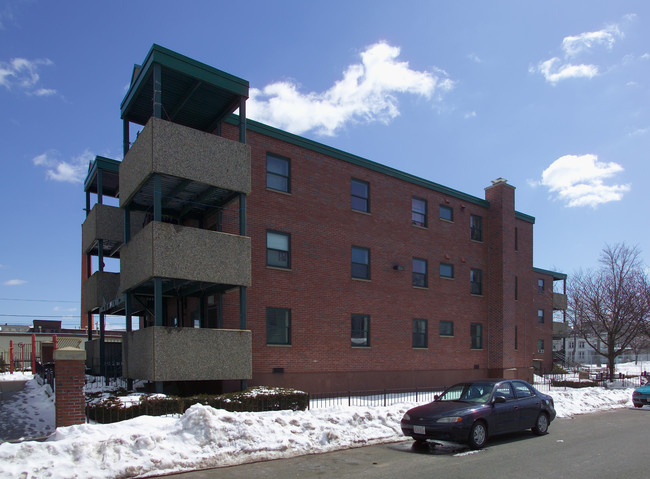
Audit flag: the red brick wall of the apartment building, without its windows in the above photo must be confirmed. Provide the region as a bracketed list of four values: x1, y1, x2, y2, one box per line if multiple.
[218, 124, 550, 392]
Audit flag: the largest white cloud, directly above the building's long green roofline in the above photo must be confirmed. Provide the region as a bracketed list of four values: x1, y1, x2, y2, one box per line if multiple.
[246, 42, 453, 136]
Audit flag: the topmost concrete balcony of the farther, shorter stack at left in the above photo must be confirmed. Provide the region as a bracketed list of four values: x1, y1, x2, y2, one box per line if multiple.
[81, 204, 124, 256]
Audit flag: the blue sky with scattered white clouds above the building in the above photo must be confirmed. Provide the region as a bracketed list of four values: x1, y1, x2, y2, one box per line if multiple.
[0, 0, 650, 327]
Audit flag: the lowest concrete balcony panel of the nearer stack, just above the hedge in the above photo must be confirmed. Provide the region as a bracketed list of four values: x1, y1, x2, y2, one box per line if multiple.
[122, 326, 253, 381]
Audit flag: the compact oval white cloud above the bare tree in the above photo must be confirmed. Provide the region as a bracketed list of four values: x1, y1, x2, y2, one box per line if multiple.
[540, 154, 630, 208]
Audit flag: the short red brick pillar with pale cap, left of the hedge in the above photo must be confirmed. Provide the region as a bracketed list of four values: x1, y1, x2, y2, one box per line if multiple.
[54, 348, 86, 427]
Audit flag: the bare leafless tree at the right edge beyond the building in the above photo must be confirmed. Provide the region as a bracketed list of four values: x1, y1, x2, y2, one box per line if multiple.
[567, 244, 650, 378]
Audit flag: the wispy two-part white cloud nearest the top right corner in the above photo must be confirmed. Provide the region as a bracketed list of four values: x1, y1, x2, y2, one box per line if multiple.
[529, 18, 627, 85]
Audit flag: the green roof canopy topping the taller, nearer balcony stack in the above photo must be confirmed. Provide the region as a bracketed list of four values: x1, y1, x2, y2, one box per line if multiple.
[120, 44, 249, 132]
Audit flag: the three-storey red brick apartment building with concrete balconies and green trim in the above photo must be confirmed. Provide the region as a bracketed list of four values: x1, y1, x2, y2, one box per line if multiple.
[82, 45, 566, 392]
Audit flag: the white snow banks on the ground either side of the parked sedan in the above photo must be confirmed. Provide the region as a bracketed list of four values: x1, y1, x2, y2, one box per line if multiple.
[0, 363, 650, 478]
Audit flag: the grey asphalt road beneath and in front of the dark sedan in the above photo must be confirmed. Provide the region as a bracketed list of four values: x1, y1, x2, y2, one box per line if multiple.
[163, 407, 650, 479]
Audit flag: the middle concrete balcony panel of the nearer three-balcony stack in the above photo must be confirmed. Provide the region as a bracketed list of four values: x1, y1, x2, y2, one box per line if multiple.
[120, 221, 251, 292]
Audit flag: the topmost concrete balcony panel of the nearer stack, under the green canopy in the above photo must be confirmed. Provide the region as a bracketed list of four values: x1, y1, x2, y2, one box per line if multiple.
[120, 118, 251, 206]
